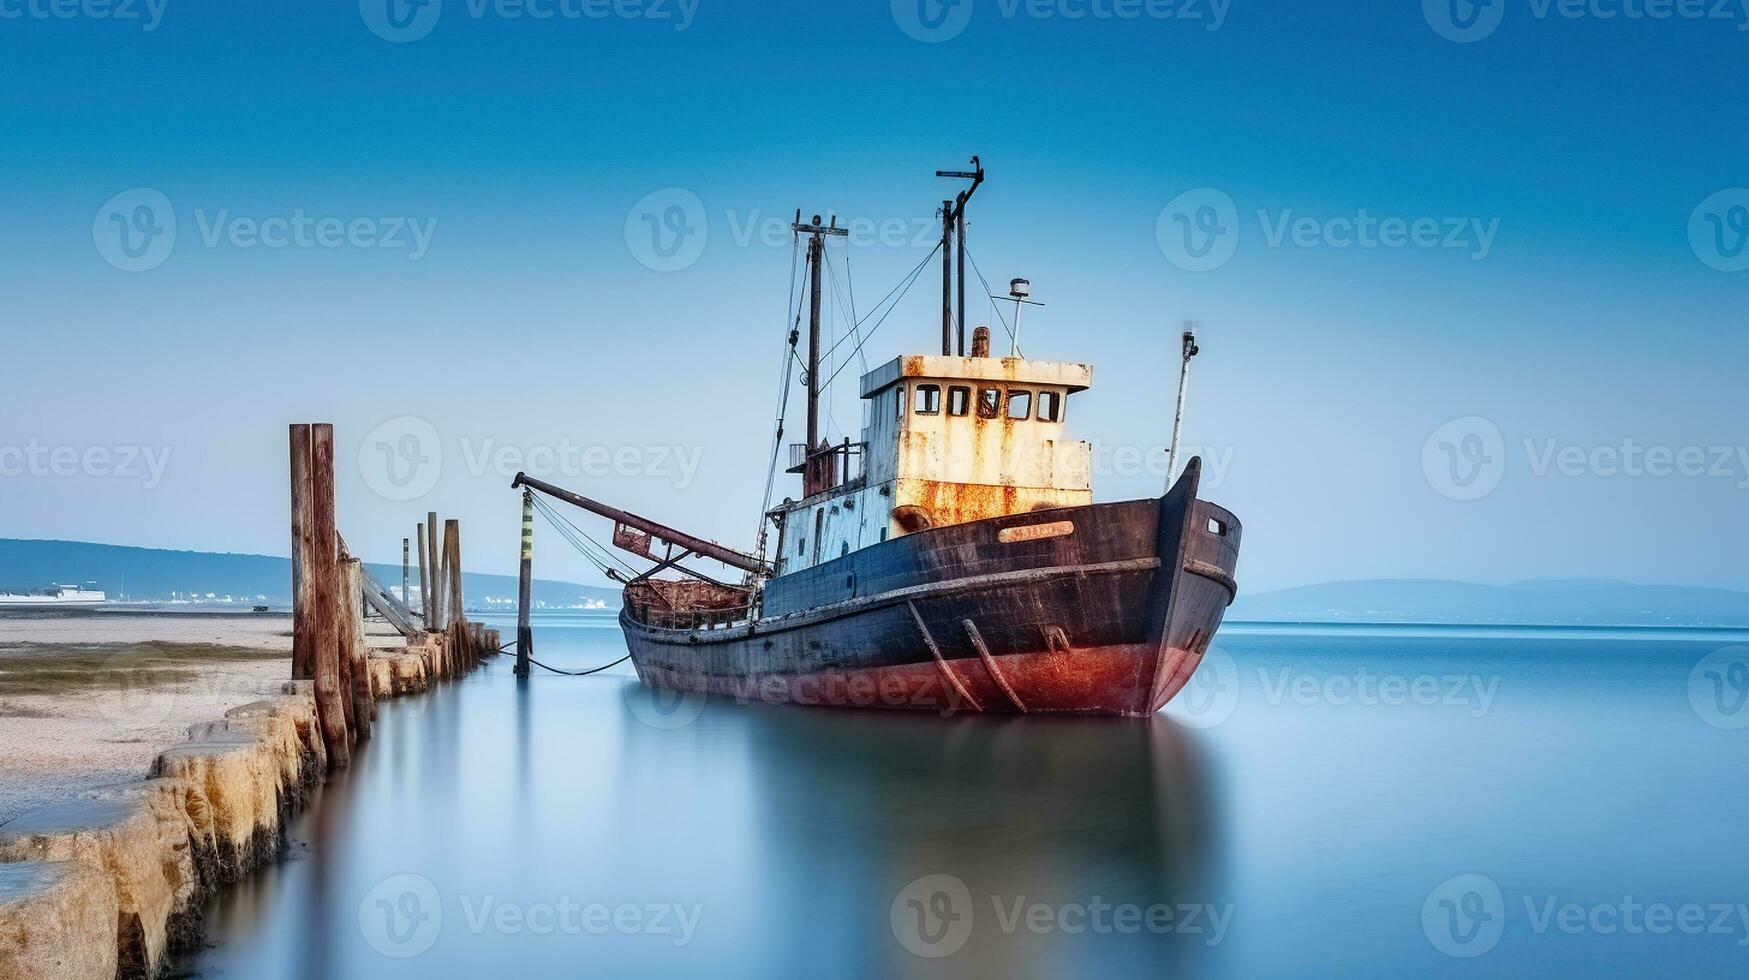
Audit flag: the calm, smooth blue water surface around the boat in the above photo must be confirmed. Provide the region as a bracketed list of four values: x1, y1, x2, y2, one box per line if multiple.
[184, 614, 1749, 978]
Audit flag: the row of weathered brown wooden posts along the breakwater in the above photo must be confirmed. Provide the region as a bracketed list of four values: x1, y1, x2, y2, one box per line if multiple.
[290, 422, 491, 768]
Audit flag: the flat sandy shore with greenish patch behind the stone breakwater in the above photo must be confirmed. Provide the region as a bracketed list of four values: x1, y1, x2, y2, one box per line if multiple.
[0, 614, 402, 824]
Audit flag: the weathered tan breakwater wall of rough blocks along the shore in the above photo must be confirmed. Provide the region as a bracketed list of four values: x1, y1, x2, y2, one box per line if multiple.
[0, 630, 500, 980]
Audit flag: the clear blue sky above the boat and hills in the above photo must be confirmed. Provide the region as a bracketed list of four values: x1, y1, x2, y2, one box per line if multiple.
[0, 0, 1749, 590]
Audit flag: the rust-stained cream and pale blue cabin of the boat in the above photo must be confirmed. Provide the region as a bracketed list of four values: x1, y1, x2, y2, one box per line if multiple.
[771, 347, 1093, 576]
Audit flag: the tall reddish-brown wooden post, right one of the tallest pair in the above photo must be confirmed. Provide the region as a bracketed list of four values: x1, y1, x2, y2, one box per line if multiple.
[304, 422, 352, 768]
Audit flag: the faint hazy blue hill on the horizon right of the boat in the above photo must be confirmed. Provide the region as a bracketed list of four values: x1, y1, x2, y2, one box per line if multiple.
[1226, 579, 1749, 627]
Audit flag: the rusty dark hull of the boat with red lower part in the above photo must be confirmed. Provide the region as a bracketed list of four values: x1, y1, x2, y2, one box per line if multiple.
[619, 460, 1240, 718]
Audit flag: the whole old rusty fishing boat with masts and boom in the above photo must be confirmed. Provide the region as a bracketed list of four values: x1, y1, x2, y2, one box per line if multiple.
[514, 158, 1240, 716]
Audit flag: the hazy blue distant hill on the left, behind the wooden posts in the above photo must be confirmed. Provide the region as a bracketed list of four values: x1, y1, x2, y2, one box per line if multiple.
[0, 537, 619, 607]
